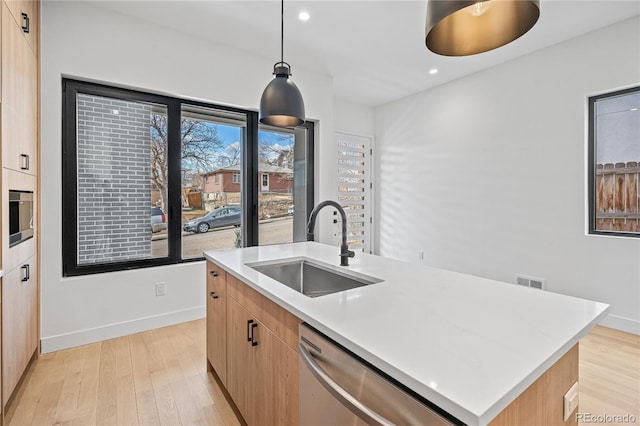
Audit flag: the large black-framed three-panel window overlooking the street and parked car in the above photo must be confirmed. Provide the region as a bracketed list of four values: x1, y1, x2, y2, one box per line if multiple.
[62, 79, 313, 276]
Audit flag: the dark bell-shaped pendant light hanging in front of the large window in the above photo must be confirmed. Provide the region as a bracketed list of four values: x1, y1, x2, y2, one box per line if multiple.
[259, 0, 305, 127]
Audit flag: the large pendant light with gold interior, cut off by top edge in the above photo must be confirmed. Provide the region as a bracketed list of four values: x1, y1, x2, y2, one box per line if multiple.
[425, 0, 540, 56]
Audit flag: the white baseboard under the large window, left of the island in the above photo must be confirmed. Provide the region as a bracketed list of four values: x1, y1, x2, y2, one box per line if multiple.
[40, 306, 206, 354]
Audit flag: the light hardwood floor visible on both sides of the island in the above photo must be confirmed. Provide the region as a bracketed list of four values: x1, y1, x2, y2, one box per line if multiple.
[5, 320, 640, 426]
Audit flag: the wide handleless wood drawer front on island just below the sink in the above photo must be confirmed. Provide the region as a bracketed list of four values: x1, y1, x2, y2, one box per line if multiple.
[227, 275, 302, 352]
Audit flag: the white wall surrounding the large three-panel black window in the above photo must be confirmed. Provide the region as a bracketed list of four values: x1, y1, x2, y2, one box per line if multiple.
[41, 1, 335, 352]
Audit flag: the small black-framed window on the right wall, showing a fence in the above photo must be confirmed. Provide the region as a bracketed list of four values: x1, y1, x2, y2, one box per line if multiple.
[589, 87, 640, 237]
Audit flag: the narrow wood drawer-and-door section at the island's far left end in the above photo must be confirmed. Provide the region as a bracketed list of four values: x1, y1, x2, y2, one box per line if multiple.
[206, 262, 227, 385]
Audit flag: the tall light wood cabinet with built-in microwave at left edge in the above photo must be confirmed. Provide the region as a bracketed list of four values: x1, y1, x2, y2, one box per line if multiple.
[0, 0, 40, 424]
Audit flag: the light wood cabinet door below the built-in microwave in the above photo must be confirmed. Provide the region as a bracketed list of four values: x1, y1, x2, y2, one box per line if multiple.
[2, 256, 38, 405]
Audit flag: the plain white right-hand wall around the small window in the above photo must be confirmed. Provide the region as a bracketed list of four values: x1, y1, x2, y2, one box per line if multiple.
[376, 17, 640, 333]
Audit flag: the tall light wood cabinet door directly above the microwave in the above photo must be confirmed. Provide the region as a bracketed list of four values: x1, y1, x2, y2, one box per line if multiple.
[1, 2, 38, 175]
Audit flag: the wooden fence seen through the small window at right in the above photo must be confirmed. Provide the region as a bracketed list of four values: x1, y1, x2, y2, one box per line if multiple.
[595, 161, 640, 232]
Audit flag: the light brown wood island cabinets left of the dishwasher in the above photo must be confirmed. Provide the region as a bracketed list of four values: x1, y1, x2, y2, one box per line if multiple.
[207, 262, 301, 426]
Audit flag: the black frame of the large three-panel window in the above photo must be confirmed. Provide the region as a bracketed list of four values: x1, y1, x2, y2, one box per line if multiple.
[61, 77, 314, 277]
